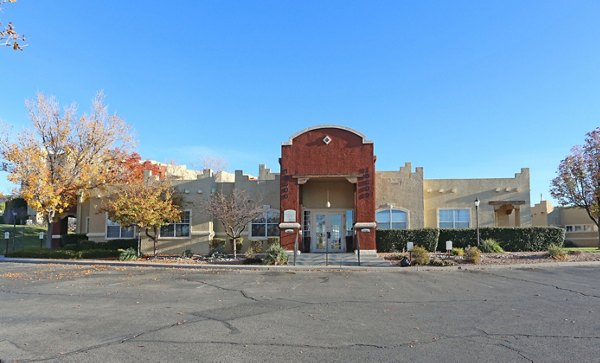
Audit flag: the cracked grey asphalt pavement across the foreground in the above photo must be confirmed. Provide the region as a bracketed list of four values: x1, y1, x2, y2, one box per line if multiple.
[0, 263, 600, 362]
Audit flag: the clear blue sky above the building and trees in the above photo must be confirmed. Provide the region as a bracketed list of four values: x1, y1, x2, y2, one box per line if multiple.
[0, 0, 600, 202]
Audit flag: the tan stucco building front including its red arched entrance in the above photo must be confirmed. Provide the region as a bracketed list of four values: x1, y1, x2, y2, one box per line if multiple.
[76, 125, 532, 254]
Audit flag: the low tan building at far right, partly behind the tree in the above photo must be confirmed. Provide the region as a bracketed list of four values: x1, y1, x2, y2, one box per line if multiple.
[531, 200, 598, 247]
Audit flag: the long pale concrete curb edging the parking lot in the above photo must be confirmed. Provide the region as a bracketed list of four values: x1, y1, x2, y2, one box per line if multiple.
[0, 256, 600, 272]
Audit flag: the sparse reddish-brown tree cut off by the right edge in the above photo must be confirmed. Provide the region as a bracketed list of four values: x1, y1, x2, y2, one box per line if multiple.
[550, 127, 600, 249]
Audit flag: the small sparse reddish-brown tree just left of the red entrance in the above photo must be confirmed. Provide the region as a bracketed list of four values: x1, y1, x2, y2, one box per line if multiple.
[206, 189, 263, 258]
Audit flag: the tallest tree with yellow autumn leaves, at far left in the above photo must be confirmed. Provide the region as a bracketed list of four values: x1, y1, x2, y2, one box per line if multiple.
[0, 92, 131, 247]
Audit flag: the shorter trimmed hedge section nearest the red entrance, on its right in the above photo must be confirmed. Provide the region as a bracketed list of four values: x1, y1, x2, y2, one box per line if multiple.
[375, 228, 439, 252]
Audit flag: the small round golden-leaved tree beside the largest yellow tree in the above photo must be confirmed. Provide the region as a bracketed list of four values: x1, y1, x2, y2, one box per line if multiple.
[101, 177, 181, 257]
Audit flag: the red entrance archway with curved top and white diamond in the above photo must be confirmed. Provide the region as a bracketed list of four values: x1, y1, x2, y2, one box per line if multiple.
[280, 125, 376, 252]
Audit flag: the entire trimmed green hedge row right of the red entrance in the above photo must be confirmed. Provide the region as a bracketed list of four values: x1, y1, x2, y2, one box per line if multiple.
[377, 227, 565, 252]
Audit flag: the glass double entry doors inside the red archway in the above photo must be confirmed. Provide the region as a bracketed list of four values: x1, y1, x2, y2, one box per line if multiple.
[310, 212, 346, 252]
